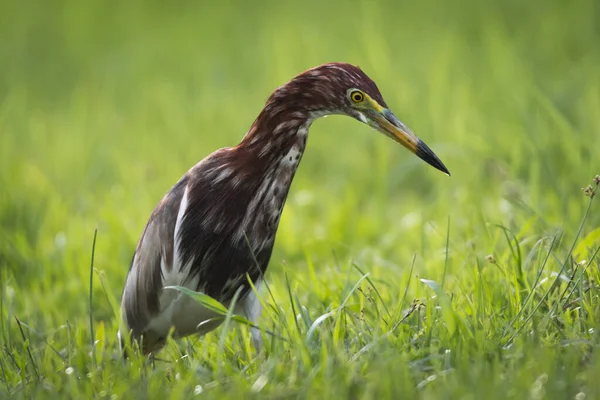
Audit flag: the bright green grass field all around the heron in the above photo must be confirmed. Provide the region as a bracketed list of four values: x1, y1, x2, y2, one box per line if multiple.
[0, 0, 600, 400]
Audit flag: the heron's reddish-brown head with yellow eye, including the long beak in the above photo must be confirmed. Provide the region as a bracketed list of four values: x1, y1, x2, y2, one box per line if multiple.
[282, 63, 450, 175]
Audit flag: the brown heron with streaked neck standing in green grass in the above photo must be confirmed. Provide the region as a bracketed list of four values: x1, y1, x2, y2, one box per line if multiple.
[118, 62, 450, 355]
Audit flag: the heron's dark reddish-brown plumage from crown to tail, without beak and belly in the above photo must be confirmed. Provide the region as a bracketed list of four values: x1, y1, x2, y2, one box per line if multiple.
[122, 63, 385, 351]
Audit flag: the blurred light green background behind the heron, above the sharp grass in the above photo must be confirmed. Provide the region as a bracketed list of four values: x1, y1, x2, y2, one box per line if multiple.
[0, 0, 600, 398]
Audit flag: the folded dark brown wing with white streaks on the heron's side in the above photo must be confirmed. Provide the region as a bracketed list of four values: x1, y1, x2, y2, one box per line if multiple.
[121, 149, 274, 335]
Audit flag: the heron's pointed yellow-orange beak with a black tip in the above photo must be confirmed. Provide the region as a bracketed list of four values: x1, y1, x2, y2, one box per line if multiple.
[371, 107, 450, 176]
